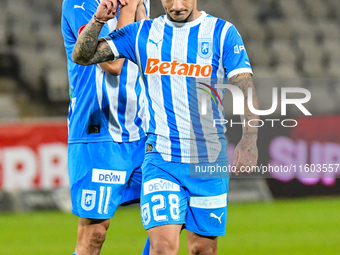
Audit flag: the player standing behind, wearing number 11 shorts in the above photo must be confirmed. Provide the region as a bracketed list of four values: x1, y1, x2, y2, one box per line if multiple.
[61, 0, 149, 255]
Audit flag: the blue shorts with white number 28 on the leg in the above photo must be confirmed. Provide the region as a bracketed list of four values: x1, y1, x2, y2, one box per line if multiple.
[141, 153, 229, 236]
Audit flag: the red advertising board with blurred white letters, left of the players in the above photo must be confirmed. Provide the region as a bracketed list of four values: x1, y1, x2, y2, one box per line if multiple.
[0, 120, 69, 191]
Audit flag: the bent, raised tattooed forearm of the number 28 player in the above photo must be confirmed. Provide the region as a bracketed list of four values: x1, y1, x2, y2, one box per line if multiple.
[72, 18, 114, 65]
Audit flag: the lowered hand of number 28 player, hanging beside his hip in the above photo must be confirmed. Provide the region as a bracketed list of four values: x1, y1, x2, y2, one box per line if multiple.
[233, 137, 258, 175]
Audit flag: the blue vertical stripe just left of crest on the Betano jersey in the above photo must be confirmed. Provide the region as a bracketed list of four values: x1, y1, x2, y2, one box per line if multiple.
[186, 25, 208, 161]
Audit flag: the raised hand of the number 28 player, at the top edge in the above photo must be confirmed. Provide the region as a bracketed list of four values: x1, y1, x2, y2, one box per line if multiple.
[95, 0, 129, 21]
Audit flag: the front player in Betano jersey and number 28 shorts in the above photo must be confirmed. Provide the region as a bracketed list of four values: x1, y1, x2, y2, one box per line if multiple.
[73, 0, 258, 255]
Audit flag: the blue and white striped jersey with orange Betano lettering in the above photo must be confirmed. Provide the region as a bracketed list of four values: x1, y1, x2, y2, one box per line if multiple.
[106, 12, 252, 163]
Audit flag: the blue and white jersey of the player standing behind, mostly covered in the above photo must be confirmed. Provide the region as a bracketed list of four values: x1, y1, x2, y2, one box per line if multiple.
[61, 0, 149, 143]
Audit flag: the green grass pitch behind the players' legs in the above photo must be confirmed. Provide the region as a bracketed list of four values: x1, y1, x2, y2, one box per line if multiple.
[0, 198, 340, 255]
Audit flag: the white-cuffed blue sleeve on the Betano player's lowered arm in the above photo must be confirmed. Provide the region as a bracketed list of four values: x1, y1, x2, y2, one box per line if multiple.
[223, 25, 253, 79]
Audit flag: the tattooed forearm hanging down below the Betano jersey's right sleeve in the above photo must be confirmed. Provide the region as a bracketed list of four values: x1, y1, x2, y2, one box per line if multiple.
[229, 73, 259, 137]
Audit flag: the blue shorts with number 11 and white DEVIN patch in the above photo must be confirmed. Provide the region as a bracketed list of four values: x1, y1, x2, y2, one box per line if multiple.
[68, 138, 146, 219]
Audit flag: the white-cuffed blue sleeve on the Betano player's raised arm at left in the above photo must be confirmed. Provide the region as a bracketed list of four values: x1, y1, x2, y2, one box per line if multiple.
[104, 22, 141, 64]
